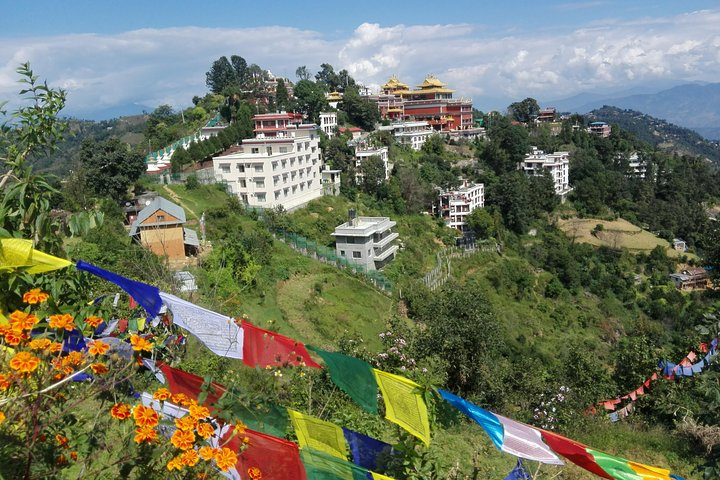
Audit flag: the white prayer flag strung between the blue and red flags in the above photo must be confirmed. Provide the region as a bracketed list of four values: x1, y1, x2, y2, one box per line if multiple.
[160, 292, 243, 360]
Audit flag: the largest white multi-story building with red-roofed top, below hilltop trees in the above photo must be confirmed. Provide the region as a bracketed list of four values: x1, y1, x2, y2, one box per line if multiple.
[213, 112, 323, 210]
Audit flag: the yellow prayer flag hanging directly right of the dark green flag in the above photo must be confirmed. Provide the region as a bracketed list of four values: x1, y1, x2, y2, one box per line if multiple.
[373, 369, 430, 445]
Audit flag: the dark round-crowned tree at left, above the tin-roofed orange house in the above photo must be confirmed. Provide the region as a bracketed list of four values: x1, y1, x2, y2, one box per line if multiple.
[80, 138, 145, 201]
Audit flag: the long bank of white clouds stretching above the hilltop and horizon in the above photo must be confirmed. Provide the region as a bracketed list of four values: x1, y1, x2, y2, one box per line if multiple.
[0, 9, 720, 116]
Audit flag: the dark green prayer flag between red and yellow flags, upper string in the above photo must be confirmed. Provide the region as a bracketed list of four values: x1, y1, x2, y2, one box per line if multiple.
[306, 345, 378, 414]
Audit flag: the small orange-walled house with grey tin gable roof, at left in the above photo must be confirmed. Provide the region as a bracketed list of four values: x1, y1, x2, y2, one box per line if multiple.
[130, 197, 200, 263]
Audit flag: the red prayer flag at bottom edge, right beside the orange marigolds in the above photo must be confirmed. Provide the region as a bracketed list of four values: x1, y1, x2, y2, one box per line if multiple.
[220, 427, 307, 480]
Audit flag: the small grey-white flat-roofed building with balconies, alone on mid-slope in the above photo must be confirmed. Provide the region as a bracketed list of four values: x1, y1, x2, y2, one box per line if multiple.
[332, 211, 398, 271]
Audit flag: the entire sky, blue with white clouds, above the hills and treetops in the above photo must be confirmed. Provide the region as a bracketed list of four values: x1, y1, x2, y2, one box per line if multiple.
[0, 0, 720, 118]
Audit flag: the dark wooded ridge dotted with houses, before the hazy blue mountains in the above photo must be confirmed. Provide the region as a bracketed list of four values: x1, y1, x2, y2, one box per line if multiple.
[585, 106, 720, 165]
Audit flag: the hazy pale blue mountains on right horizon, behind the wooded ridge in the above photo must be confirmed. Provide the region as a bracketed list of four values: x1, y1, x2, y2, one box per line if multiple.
[543, 83, 720, 140]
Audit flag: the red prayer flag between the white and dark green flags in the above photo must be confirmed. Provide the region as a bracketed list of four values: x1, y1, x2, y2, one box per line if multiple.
[242, 320, 322, 368]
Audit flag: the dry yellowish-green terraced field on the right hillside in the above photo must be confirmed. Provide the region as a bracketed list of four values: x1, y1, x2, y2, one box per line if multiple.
[558, 218, 683, 257]
